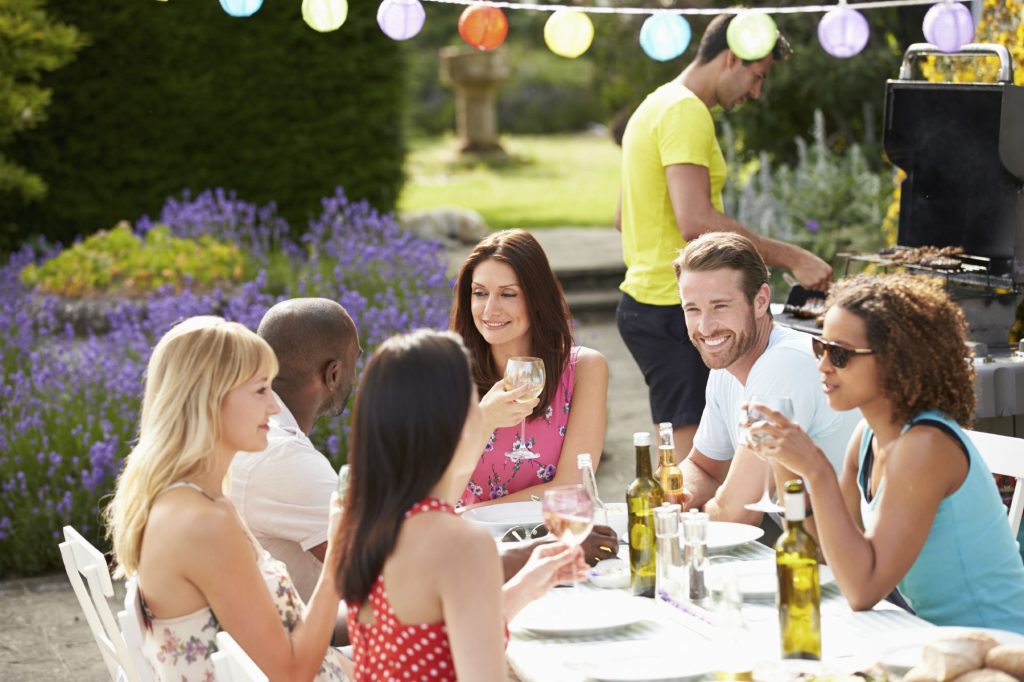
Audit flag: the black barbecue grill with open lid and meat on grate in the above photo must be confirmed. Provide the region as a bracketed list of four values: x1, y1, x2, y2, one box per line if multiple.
[782, 43, 1024, 352]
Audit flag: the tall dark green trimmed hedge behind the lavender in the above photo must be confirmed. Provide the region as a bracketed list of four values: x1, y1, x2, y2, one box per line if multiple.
[0, 0, 407, 251]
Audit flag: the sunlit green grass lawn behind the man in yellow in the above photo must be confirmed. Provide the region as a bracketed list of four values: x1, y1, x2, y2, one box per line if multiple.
[398, 133, 621, 229]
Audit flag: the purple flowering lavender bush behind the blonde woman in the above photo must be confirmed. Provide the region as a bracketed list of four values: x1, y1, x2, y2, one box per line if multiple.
[0, 188, 450, 574]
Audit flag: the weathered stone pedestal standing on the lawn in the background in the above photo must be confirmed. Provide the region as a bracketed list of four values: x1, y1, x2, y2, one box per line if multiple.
[440, 46, 509, 155]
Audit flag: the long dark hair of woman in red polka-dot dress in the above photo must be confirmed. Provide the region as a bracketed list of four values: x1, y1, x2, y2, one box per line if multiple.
[336, 330, 473, 604]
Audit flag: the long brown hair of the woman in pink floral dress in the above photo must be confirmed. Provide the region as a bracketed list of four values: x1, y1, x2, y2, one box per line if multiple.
[449, 229, 572, 417]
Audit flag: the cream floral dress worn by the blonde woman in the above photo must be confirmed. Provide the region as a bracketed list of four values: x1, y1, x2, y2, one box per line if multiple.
[139, 484, 348, 682]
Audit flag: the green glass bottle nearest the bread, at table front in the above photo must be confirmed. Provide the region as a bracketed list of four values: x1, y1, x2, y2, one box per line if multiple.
[775, 479, 821, 660]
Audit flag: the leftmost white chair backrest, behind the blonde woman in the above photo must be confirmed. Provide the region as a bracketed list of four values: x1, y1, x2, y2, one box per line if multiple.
[60, 525, 141, 682]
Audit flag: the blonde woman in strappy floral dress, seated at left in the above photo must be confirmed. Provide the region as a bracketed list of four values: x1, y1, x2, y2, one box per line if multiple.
[108, 316, 346, 681]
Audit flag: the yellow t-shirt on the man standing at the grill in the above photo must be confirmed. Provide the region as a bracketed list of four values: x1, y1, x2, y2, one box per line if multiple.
[620, 82, 726, 305]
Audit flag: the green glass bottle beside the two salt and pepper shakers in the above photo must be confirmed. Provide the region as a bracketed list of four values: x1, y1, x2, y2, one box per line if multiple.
[626, 431, 665, 597]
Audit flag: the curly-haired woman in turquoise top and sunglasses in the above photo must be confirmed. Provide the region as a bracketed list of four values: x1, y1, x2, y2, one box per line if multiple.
[752, 274, 1024, 633]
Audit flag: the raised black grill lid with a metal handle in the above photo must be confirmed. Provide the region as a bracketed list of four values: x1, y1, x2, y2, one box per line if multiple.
[883, 43, 1024, 282]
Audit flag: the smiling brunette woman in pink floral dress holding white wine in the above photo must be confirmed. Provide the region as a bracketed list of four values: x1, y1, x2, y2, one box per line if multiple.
[451, 229, 608, 507]
